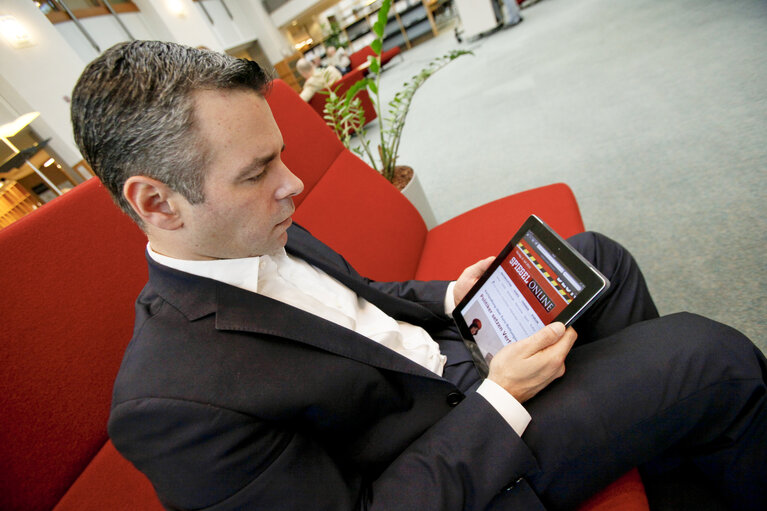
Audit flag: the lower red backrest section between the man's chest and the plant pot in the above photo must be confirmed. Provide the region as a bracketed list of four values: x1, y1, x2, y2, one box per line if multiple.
[293, 150, 426, 281]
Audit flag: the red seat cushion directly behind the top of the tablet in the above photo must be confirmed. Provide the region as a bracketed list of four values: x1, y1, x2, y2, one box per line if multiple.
[416, 183, 584, 280]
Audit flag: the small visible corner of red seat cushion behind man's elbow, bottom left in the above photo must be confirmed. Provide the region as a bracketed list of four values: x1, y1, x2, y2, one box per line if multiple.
[53, 441, 164, 511]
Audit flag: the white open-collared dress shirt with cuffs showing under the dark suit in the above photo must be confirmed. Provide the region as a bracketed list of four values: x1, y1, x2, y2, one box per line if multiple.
[147, 245, 531, 436]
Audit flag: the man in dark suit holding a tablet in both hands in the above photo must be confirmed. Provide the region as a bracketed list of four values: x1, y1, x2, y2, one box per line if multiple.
[72, 41, 767, 511]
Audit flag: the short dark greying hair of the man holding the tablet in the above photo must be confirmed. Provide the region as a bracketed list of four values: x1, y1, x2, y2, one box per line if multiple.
[72, 41, 270, 225]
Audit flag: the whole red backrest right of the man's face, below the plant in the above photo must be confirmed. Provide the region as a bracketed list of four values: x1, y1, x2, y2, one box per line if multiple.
[267, 80, 426, 280]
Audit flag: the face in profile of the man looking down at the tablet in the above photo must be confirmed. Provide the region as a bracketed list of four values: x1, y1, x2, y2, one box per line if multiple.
[179, 90, 304, 259]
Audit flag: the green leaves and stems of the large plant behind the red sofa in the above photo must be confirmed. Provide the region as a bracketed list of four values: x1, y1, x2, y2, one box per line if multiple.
[323, 0, 473, 224]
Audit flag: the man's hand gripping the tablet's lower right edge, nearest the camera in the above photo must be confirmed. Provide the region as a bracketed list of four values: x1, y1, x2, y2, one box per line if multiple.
[488, 323, 578, 403]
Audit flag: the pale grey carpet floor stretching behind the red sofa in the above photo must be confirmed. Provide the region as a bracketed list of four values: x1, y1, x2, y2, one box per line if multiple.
[360, 0, 767, 352]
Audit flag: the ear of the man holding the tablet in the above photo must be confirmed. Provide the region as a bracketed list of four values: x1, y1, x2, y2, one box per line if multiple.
[123, 176, 184, 231]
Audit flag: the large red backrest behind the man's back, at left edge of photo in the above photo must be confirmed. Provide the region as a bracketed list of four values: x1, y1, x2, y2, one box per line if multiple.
[0, 179, 147, 511]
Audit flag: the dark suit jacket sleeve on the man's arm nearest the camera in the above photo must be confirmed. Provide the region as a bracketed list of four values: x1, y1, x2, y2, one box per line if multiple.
[109, 394, 535, 511]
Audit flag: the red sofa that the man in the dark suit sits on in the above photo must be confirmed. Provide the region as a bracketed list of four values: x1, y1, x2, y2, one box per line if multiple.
[0, 77, 648, 511]
